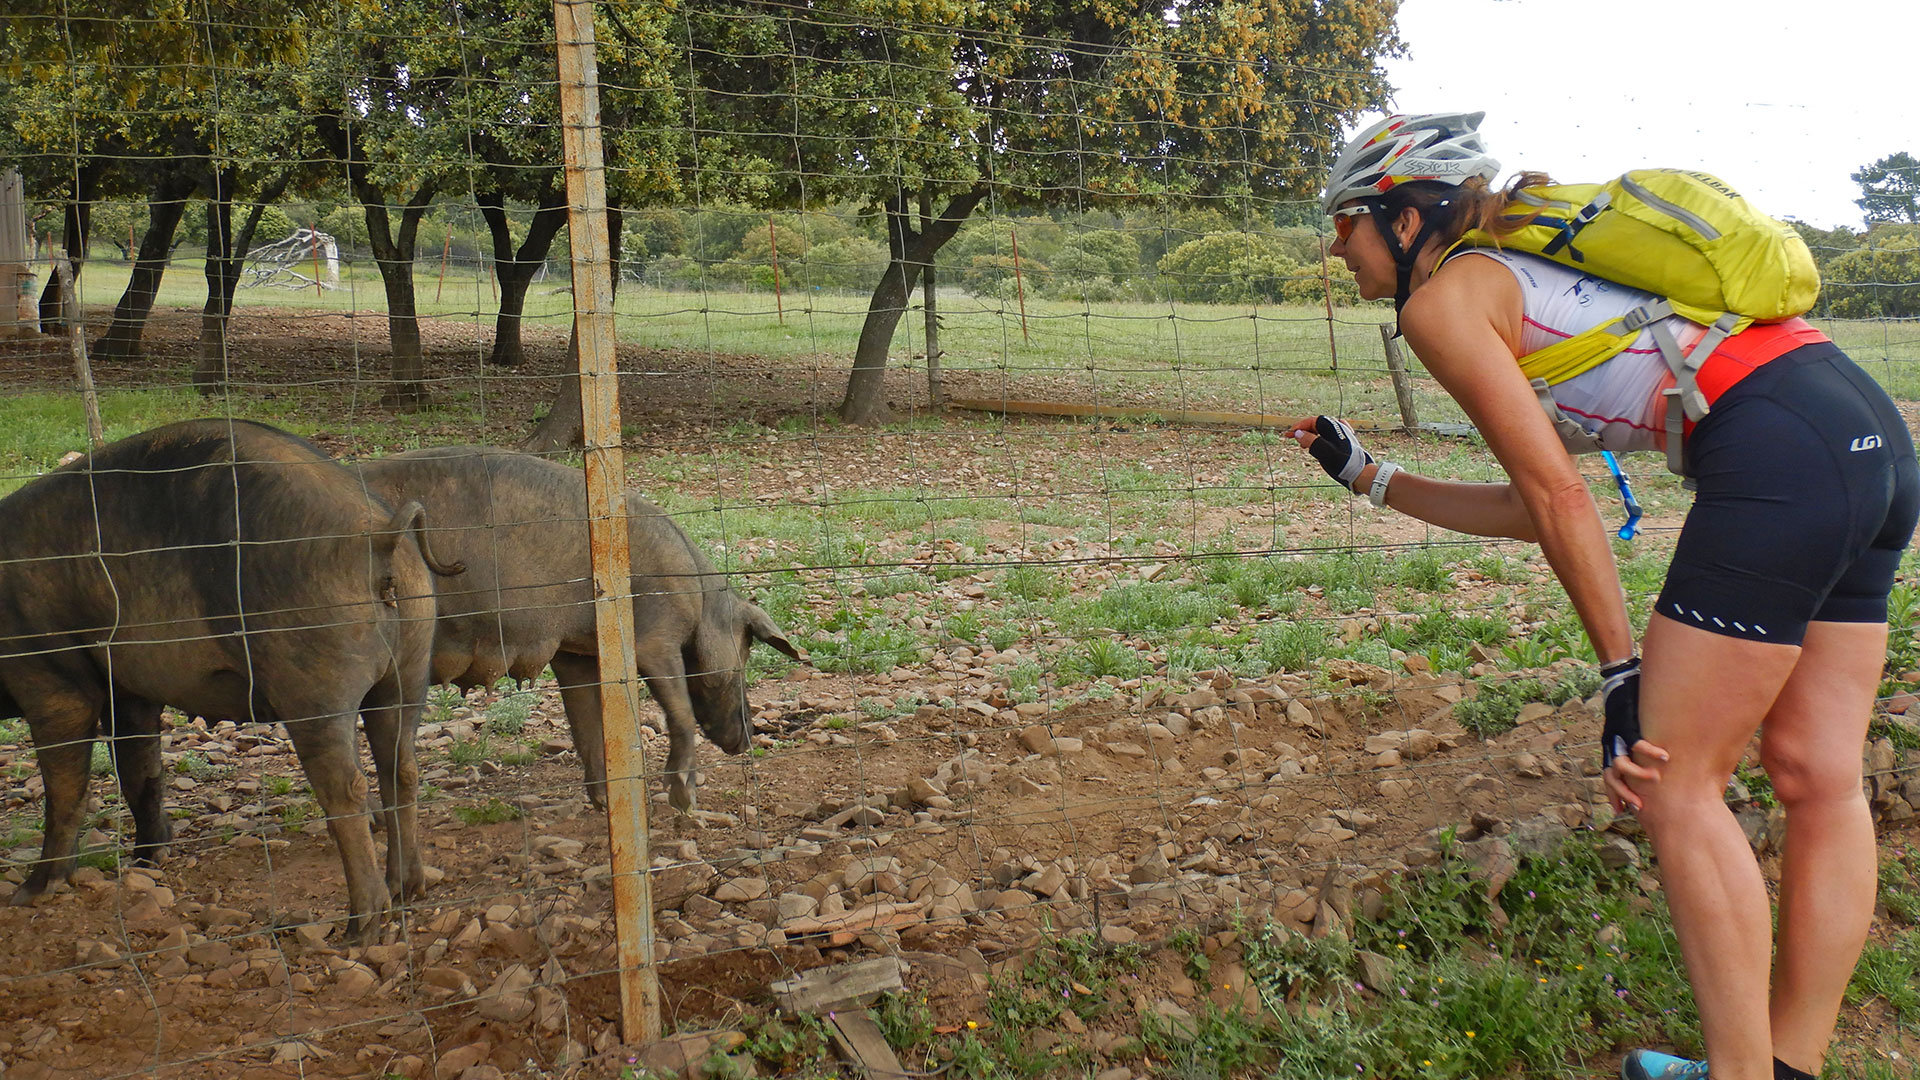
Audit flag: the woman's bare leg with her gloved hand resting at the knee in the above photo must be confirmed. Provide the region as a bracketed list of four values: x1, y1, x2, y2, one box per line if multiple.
[1634, 615, 1801, 1080]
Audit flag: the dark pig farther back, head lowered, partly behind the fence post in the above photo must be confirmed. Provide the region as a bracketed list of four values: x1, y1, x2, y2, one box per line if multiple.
[355, 446, 806, 811]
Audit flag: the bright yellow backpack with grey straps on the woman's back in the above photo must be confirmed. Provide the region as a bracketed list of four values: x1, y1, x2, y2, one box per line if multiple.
[1448, 169, 1820, 473]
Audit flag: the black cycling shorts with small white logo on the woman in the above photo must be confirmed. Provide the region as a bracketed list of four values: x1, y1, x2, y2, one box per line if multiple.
[1655, 342, 1920, 646]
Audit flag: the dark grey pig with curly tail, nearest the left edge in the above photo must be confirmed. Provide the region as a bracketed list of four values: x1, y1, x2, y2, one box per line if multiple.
[0, 421, 459, 938]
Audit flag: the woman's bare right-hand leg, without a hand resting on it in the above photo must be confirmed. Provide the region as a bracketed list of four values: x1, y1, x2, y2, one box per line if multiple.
[1761, 623, 1887, 1076]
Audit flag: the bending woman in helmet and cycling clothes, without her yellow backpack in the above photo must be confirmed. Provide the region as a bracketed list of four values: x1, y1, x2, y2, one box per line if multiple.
[1290, 113, 1920, 1080]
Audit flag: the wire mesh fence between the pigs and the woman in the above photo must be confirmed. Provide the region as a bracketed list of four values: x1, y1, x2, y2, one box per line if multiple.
[0, 0, 1920, 1080]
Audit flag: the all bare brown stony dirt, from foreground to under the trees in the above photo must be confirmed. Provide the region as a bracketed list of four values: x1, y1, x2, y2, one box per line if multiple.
[0, 311, 1920, 1080]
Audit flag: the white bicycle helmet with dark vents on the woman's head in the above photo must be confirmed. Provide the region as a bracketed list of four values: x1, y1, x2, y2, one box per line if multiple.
[1321, 111, 1500, 213]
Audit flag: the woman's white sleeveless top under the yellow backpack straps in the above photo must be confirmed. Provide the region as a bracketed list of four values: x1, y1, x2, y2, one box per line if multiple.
[1463, 248, 1705, 452]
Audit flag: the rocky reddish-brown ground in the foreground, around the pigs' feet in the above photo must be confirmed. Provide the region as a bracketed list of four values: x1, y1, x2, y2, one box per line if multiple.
[11, 648, 1920, 1080]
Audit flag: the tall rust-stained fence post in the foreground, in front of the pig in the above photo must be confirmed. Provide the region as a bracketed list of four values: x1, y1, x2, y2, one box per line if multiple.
[553, 0, 660, 1043]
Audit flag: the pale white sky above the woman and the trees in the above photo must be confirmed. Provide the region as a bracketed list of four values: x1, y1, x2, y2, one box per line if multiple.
[1350, 0, 1920, 229]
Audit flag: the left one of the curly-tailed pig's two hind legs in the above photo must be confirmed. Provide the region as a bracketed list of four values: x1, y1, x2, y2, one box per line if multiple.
[273, 703, 392, 942]
